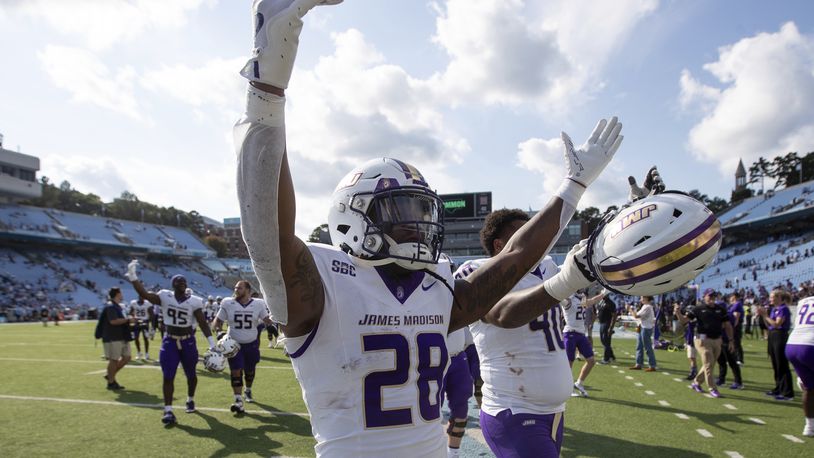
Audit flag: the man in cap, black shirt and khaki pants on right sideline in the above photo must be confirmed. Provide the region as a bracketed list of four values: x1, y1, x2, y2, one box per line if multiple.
[673, 288, 735, 398]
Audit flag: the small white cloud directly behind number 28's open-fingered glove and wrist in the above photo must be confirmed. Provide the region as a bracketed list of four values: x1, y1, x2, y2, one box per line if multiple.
[517, 133, 628, 211]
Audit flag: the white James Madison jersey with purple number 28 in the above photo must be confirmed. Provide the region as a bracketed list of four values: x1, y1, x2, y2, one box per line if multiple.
[285, 244, 452, 458]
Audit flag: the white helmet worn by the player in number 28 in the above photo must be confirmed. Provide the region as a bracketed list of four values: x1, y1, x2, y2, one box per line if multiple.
[328, 158, 444, 270]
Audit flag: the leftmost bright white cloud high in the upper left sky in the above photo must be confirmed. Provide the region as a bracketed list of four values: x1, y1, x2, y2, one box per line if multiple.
[37, 45, 145, 120]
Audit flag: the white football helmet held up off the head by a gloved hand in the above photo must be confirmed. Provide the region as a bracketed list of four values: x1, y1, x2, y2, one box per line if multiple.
[587, 191, 722, 296]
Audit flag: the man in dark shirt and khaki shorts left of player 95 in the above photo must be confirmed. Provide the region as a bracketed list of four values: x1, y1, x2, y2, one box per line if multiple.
[102, 288, 136, 390]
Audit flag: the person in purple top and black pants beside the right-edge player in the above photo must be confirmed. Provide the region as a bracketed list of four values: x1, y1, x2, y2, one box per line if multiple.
[758, 289, 794, 401]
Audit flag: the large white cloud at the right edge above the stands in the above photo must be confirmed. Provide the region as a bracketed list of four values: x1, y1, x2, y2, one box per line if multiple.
[680, 22, 814, 176]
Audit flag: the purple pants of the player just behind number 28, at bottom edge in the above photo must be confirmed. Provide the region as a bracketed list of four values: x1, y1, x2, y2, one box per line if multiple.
[480, 409, 564, 458]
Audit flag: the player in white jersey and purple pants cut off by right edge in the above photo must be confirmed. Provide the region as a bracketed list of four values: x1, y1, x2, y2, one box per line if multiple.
[786, 296, 814, 437]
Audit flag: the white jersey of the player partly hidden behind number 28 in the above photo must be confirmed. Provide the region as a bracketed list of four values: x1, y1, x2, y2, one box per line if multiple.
[455, 256, 573, 416]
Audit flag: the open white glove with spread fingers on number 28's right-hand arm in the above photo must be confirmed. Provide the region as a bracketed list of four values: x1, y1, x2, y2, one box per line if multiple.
[560, 116, 624, 188]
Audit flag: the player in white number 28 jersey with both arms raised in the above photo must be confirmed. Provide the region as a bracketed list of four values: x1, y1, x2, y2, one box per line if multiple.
[235, 0, 622, 458]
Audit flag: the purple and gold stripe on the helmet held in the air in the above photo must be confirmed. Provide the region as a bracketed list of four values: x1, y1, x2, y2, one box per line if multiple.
[600, 215, 721, 285]
